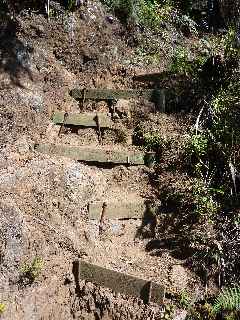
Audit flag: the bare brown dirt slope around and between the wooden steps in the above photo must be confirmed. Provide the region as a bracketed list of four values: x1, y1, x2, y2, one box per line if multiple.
[0, 1, 202, 320]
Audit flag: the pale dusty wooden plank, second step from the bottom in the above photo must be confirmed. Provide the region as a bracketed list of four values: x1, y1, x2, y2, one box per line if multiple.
[88, 199, 154, 219]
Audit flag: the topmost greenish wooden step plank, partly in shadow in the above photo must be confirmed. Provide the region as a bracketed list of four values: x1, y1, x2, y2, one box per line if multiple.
[70, 88, 164, 102]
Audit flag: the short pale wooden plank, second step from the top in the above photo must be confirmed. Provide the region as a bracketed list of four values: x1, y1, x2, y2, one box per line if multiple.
[52, 111, 113, 128]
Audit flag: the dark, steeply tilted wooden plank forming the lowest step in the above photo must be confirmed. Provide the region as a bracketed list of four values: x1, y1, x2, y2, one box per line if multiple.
[79, 260, 165, 303]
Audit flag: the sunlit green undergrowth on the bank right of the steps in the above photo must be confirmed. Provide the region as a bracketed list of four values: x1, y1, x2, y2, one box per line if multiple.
[150, 19, 240, 320]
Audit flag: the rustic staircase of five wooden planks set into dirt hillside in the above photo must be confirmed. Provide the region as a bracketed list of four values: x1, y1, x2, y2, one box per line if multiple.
[34, 89, 165, 303]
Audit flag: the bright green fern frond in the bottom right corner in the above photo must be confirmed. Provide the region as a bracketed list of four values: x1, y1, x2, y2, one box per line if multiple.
[213, 287, 240, 313]
